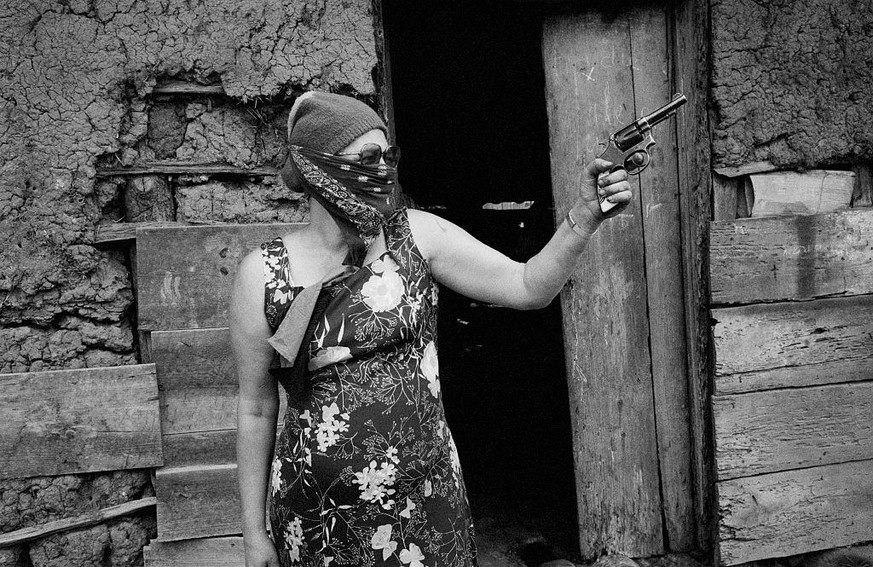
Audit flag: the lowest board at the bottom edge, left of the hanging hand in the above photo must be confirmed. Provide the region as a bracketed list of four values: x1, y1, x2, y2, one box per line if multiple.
[142, 537, 246, 567]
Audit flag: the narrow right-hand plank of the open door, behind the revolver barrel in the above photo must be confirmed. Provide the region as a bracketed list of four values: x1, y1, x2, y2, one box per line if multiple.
[629, 7, 695, 552]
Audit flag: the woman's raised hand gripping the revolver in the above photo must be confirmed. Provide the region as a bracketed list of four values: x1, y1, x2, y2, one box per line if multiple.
[573, 158, 633, 234]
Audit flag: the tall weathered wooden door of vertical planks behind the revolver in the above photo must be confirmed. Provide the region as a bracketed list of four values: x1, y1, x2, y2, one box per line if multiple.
[543, 6, 695, 557]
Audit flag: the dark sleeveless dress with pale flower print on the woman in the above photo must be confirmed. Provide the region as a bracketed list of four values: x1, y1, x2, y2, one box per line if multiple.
[262, 209, 476, 567]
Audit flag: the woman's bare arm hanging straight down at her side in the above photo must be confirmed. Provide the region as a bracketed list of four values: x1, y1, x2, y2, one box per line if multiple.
[230, 250, 279, 567]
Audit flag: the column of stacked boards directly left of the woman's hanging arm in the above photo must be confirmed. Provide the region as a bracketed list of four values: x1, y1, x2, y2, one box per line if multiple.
[137, 224, 299, 544]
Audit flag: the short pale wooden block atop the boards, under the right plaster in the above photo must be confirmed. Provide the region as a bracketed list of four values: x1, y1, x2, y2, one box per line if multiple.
[749, 170, 855, 217]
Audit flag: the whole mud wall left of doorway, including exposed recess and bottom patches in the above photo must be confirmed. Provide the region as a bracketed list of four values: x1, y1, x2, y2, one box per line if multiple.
[0, 0, 378, 567]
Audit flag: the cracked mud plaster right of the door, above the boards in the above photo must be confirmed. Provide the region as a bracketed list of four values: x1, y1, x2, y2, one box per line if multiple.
[712, 0, 873, 169]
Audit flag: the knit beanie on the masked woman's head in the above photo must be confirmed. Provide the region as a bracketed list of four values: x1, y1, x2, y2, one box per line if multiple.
[288, 91, 387, 154]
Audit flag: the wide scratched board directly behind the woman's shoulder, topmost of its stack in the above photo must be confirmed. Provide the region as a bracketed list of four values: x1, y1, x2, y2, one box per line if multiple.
[136, 223, 303, 331]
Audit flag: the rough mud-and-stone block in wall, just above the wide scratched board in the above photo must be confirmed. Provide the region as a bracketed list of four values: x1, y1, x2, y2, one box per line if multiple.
[176, 178, 307, 223]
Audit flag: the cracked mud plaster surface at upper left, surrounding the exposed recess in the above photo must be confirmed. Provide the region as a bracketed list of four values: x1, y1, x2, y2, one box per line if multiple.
[0, 0, 376, 371]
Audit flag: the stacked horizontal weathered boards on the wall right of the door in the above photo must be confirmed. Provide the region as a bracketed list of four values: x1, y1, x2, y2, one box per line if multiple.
[711, 210, 873, 565]
